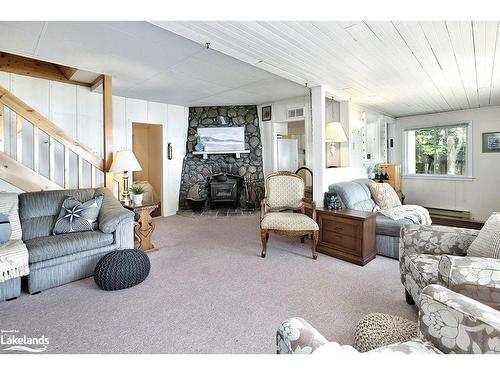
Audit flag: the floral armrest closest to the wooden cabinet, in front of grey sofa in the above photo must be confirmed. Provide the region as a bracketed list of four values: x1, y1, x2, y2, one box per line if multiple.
[399, 225, 479, 256]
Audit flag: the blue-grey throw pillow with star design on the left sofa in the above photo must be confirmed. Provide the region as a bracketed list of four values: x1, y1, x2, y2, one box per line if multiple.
[53, 194, 104, 234]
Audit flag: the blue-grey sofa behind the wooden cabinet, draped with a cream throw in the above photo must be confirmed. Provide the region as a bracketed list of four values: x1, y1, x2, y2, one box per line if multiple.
[328, 178, 413, 259]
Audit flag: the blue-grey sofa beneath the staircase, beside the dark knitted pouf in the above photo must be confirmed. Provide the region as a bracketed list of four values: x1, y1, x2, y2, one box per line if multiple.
[0, 188, 134, 300]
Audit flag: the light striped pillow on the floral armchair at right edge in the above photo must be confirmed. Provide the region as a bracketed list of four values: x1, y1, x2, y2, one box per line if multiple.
[467, 212, 500, 259]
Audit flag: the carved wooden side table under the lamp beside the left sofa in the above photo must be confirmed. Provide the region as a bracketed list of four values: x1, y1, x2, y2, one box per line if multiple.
[122, 201, 159, 253]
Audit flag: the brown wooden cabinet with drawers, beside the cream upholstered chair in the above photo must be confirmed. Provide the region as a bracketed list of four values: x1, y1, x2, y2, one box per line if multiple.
[316, 208, 377, 266]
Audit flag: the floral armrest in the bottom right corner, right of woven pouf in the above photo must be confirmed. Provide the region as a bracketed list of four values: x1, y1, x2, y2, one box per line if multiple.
[418, 285, 500, 354]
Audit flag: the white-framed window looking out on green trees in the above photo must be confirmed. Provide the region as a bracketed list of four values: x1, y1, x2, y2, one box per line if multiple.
[404, 123, 472, 178]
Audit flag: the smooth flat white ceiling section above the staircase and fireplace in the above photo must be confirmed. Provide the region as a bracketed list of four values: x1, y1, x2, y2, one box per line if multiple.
[0, 22, 306, 105]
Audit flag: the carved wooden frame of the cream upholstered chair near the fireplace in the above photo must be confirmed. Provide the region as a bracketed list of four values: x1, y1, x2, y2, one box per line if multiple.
[260, 171, 319, 259]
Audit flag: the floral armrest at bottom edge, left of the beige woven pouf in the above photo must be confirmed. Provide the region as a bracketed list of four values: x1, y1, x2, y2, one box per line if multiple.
[276, 318, 328, 354]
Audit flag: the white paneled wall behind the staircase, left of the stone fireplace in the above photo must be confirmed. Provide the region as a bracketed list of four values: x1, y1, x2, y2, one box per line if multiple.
[0, 72, 187, 214]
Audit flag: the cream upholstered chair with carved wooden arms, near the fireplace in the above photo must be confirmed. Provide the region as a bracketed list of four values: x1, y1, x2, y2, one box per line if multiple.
[260, 171, 319, 259]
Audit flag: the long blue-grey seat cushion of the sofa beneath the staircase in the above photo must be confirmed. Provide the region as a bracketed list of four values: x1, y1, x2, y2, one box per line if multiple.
[25, 230, 114, 264]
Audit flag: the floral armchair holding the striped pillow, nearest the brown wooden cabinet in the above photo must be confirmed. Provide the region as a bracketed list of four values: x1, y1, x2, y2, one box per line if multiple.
[399, 225, 500, 309]
